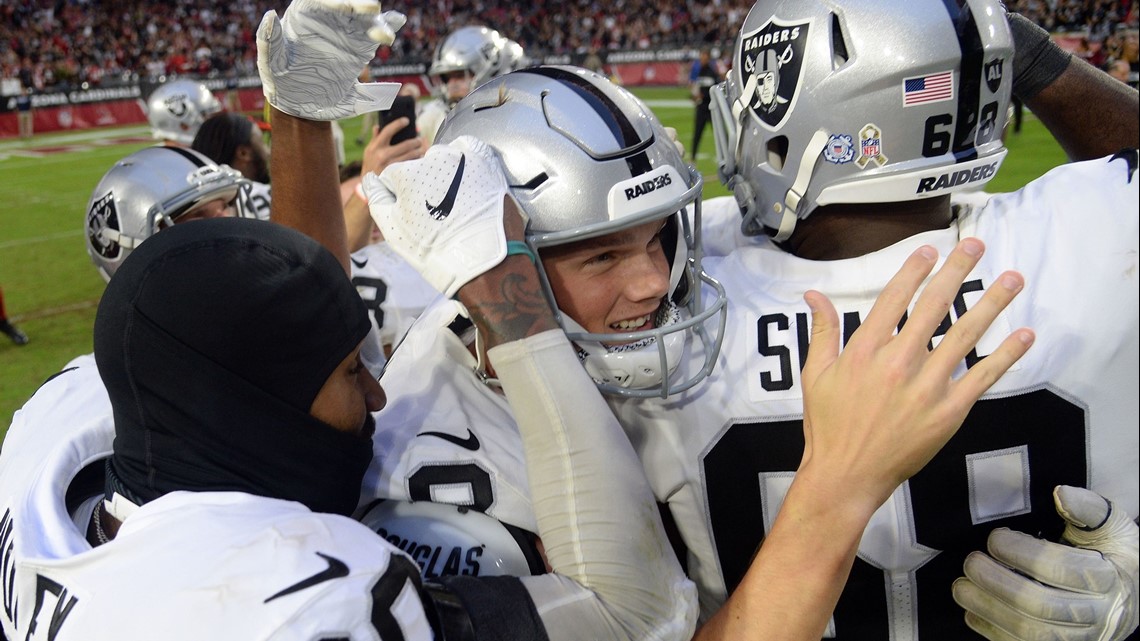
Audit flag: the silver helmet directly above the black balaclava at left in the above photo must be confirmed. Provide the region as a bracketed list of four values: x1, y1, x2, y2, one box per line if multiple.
[84, 146, 249, 281]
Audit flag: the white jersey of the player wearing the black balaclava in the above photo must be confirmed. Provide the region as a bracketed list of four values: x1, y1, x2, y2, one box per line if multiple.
[0, 366, 432, 641]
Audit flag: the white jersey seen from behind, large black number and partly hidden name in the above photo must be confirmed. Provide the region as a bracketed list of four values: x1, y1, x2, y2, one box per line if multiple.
[614, 150, 1140, 641]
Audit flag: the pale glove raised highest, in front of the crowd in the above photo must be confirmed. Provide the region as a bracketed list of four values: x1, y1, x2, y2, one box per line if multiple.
[258, 0, 407, 120]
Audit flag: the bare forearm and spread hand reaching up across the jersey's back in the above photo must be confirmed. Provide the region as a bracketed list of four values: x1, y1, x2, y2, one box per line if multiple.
[698, 238, 1034, 641]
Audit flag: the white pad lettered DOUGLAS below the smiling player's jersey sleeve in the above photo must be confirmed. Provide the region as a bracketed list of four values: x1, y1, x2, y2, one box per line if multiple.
[359, 500, 546, 579]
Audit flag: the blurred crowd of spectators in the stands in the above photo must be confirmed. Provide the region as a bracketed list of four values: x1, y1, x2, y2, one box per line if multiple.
[0, 0, 1138, 91]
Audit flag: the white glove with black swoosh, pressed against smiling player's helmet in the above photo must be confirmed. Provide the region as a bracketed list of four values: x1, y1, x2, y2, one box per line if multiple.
[361, 136, 521, 297]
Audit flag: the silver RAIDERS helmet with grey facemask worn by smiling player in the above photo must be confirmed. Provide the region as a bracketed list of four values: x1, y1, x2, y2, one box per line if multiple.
[435, 66, 726, 397]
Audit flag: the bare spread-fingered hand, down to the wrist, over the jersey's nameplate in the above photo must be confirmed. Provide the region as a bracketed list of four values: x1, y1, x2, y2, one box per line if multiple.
[798, 238, 1034, 516]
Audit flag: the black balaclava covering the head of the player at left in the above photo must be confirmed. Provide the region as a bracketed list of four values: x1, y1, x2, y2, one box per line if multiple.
[95, 218, 372, 514]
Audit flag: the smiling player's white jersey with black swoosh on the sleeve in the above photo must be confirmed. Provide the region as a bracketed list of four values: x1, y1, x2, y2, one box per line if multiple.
[364, 298, 538, 536]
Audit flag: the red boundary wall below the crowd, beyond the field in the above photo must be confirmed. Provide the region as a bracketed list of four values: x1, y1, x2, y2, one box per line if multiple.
[0, 58, 690, 138]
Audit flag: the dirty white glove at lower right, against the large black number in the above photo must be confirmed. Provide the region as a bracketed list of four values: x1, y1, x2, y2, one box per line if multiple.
[953, 485, 1140, 641]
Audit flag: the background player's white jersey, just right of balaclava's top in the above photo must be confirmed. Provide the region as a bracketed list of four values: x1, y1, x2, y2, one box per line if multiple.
[350, 241, 439, 371]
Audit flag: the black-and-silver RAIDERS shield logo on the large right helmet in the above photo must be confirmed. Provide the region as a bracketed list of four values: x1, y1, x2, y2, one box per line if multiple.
[740, 17, 808, 129]
